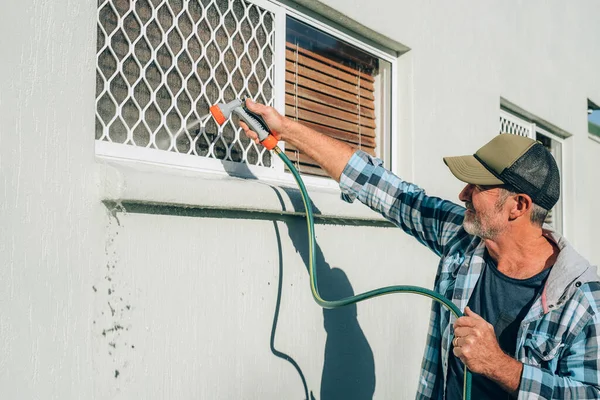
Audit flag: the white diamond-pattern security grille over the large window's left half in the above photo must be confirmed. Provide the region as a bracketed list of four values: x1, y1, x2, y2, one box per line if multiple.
[96, 0, 275, 167]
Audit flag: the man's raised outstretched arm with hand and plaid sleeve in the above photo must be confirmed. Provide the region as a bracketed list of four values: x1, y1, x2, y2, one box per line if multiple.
[240, 101, 464, 255]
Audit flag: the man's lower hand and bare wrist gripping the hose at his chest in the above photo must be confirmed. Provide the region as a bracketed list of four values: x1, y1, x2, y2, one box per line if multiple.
[452, 307, 523, 394]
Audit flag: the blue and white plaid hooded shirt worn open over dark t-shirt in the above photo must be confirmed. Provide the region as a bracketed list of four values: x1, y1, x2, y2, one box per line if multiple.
[340, 151, 600, 399]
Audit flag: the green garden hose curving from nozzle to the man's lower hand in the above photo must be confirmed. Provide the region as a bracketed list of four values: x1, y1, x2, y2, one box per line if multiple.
[273, 146, 471, 400]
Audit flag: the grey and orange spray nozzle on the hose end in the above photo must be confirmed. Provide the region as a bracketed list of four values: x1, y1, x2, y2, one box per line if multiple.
[210, 99, 277, 150]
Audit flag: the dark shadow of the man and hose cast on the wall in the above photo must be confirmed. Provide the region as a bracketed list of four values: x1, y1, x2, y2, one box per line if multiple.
[216, 157, 376, 400]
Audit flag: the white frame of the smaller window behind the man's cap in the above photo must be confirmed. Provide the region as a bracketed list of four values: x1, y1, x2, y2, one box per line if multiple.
[499, 107, 566, 234]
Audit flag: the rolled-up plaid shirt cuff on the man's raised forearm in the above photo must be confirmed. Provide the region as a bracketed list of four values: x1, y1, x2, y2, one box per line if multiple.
[340, 150, 383, 203]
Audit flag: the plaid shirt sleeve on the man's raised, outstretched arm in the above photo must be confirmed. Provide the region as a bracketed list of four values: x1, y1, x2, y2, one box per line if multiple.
[340, 150, 465, 255]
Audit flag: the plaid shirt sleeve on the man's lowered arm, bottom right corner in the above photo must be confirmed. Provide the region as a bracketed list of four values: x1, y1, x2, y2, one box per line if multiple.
[519, 284, 600, 399]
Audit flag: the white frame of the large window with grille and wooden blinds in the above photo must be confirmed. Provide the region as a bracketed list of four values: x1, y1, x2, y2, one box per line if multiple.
[95, 0, 398, 188]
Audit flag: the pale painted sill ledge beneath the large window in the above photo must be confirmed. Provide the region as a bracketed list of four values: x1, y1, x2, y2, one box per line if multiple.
[97, 156, 391, 226]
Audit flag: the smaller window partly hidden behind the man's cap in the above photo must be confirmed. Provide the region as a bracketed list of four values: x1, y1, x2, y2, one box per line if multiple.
[499, 108, 564, 233]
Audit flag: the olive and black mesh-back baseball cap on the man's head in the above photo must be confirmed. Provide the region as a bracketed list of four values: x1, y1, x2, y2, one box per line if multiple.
[444, 133, 560, 210]
